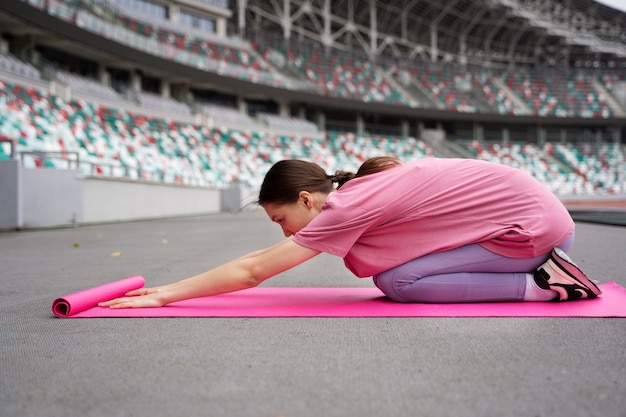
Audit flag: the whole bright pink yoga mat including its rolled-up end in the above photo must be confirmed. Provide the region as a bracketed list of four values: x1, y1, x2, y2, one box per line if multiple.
[52, 276, 626, 318]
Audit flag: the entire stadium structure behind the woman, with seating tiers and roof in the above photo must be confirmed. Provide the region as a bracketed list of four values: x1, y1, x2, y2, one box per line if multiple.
[0, 0, 626, 227]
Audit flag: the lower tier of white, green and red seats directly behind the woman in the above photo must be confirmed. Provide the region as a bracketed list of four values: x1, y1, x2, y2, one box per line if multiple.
[0, 66, 626, 195]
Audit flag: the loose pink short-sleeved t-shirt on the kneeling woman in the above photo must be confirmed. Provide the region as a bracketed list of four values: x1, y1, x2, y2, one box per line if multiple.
[293, 158, 574, 277]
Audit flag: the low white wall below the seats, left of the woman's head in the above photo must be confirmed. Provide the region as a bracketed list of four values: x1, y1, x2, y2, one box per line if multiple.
[0, 160, 224, 230]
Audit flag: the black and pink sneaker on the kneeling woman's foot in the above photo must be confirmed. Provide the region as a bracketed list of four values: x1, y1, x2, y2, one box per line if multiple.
[534, 248, 602, 301]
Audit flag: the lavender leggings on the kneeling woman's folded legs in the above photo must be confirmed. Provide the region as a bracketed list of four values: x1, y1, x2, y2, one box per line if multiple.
[374, 233, 574, 303]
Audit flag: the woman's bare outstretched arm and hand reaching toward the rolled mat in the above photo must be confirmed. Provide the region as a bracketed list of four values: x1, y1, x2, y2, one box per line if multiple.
[99, 238, 320, 308]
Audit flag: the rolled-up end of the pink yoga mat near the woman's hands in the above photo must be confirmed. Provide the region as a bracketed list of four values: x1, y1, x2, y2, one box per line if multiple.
[52, 275, 146, 318]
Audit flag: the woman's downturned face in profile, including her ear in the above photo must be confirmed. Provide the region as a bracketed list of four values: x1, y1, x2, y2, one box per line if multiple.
[263, 191, 323, 237]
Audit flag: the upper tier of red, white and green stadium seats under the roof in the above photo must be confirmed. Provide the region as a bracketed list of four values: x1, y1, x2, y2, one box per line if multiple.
[13, 0, 623, 118]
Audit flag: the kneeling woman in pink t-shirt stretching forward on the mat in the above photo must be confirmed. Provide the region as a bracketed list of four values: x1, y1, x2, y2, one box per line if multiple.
[100, 157, 601, 308]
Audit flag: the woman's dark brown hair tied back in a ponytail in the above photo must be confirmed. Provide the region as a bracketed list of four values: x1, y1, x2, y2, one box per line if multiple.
[257, 156, 400, 206]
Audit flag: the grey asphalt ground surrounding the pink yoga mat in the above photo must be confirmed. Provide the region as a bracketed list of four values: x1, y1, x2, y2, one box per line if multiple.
[0, 211, 626, 417]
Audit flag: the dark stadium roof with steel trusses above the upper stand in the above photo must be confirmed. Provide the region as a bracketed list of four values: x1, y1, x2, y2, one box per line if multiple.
[239, 0, 626, 67]
